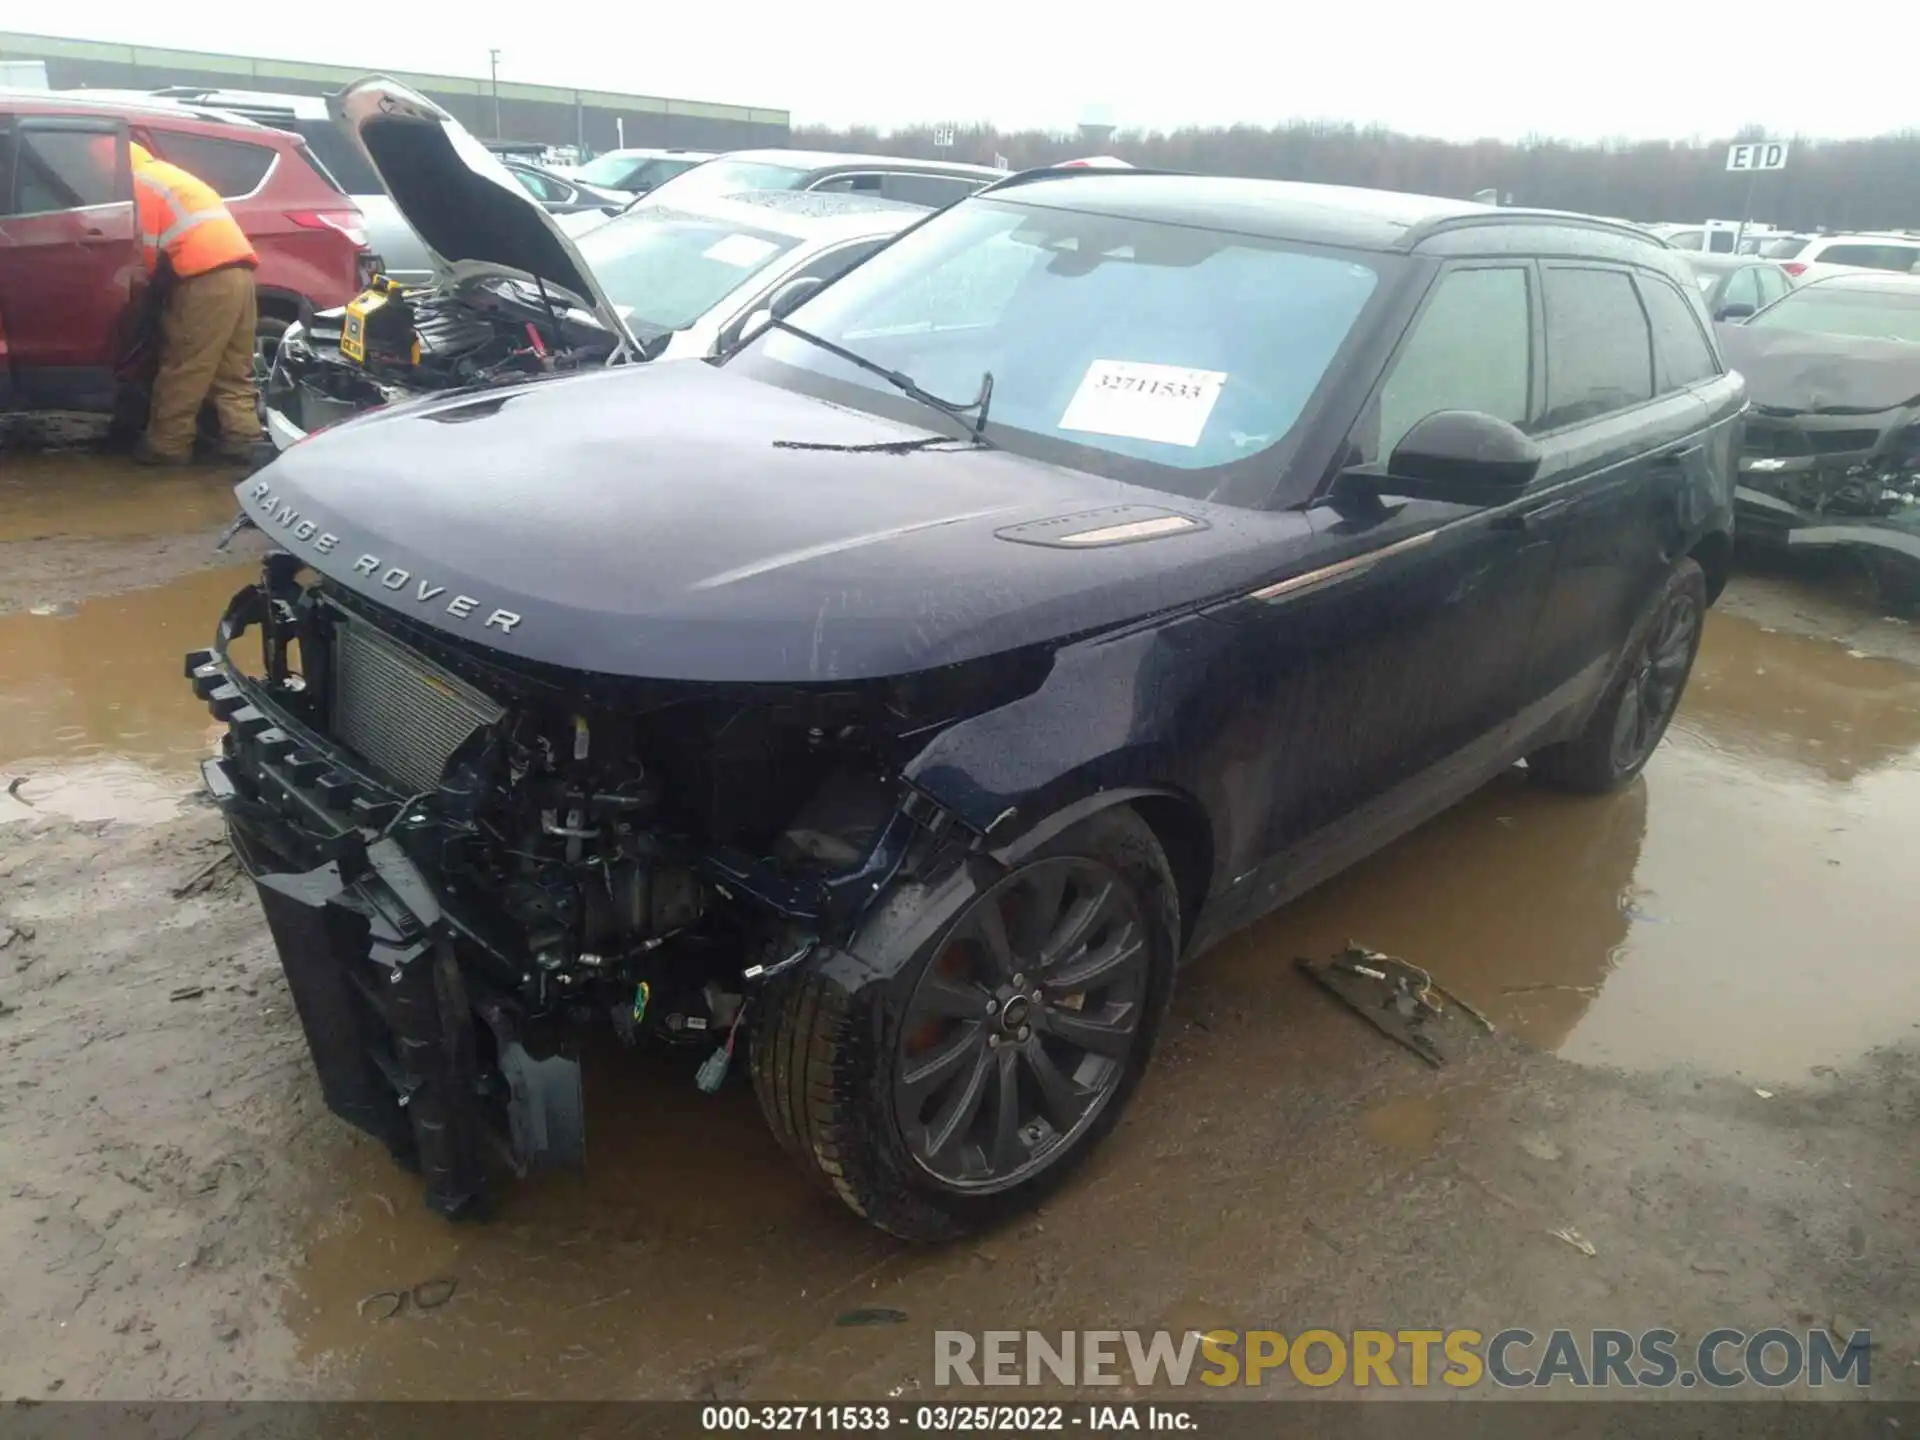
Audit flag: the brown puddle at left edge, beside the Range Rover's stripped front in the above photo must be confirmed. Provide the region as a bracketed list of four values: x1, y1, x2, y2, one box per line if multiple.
[0, 564, 253, 824]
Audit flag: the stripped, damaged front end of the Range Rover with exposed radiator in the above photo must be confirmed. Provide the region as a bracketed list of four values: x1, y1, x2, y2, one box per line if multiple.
[186, 553, 1013, 1215]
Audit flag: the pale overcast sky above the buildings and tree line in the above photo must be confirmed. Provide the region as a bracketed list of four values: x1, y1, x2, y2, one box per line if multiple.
[41, 0, 1920, 140]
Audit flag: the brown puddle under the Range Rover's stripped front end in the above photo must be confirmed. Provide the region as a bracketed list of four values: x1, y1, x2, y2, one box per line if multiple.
[282, 1041, 900, 1400]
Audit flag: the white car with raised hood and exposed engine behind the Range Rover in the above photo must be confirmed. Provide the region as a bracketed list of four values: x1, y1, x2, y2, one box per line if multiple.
[265, 77, 929, 449]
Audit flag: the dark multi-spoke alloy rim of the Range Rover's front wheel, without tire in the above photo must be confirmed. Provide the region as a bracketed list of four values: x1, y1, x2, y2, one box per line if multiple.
[893, 856, 1150, 1190]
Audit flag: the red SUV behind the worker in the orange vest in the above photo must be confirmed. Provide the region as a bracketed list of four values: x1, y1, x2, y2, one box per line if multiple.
[0, 90, 367, 434]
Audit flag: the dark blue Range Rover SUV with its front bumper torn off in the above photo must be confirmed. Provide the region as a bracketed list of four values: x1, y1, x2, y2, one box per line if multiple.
[188, 171, 1745, 1238]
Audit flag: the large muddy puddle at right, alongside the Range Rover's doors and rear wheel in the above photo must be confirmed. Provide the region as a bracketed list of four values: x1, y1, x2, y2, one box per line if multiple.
[1208, 614, 1920, 1083]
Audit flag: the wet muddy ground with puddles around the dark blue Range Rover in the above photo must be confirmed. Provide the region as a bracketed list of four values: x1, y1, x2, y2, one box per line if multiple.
[0, 457, 1920, 1398]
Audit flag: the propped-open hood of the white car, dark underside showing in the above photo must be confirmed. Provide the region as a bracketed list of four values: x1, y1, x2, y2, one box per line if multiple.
[326, 75, 637, 353]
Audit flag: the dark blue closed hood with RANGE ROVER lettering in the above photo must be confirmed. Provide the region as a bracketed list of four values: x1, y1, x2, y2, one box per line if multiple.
[236, 363, 1309, 684]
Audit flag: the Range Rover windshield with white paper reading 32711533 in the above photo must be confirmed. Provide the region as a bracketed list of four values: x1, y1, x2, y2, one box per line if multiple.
[729, 200, 1388, 503]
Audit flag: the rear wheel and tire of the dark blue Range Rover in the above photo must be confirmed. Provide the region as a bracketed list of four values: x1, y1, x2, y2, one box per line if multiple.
[1526, 559, 1707, 795]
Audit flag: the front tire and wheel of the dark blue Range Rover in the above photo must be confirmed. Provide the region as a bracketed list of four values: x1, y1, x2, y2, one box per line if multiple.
[751, 806, 1181, 1242]
